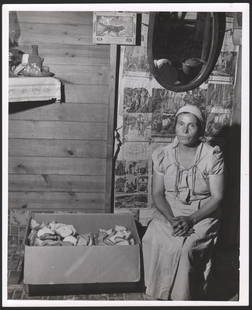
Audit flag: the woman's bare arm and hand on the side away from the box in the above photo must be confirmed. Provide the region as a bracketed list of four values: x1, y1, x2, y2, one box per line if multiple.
[174, 174, 224, 236]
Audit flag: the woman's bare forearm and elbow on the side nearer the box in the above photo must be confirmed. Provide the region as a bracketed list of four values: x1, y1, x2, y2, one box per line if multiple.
[152, 170, 174, 223]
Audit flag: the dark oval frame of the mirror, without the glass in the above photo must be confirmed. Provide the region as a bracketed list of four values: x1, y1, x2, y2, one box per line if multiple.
[147, 12, 226, 92]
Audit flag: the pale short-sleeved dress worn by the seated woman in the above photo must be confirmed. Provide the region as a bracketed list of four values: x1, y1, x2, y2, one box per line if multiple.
[142, 138, 224, 300]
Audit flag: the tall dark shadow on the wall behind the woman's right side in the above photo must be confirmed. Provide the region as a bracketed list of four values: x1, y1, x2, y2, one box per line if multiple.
[208, 124, 241, 300]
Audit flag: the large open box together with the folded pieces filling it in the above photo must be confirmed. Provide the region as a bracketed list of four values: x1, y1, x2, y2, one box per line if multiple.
[24, 213, 140, 294]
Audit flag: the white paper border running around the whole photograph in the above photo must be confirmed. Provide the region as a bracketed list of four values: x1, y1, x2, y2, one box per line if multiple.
[2, 3, 250, 307]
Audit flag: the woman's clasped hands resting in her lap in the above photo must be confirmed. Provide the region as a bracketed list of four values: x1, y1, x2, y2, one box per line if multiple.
[171, 216, 194, 237]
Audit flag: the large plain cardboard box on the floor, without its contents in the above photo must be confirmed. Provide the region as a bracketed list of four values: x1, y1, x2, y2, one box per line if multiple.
[24, 213, 141, 293]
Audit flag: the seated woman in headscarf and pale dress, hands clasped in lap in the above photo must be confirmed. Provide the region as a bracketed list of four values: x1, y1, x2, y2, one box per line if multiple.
[142, 105, 224, 300]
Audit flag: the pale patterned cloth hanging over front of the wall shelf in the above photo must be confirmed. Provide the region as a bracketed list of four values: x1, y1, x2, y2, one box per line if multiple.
[9, 77, 61, 102]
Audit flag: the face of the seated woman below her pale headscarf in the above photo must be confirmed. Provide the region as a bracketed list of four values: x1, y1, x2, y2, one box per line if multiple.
[175, 113, 200, 146]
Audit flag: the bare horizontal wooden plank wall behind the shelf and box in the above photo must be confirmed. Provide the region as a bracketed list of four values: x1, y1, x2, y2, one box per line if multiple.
[9, 11, 113, 212]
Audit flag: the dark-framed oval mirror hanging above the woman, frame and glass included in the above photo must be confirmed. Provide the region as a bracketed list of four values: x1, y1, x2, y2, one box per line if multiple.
[147, 12, 226, 92]
